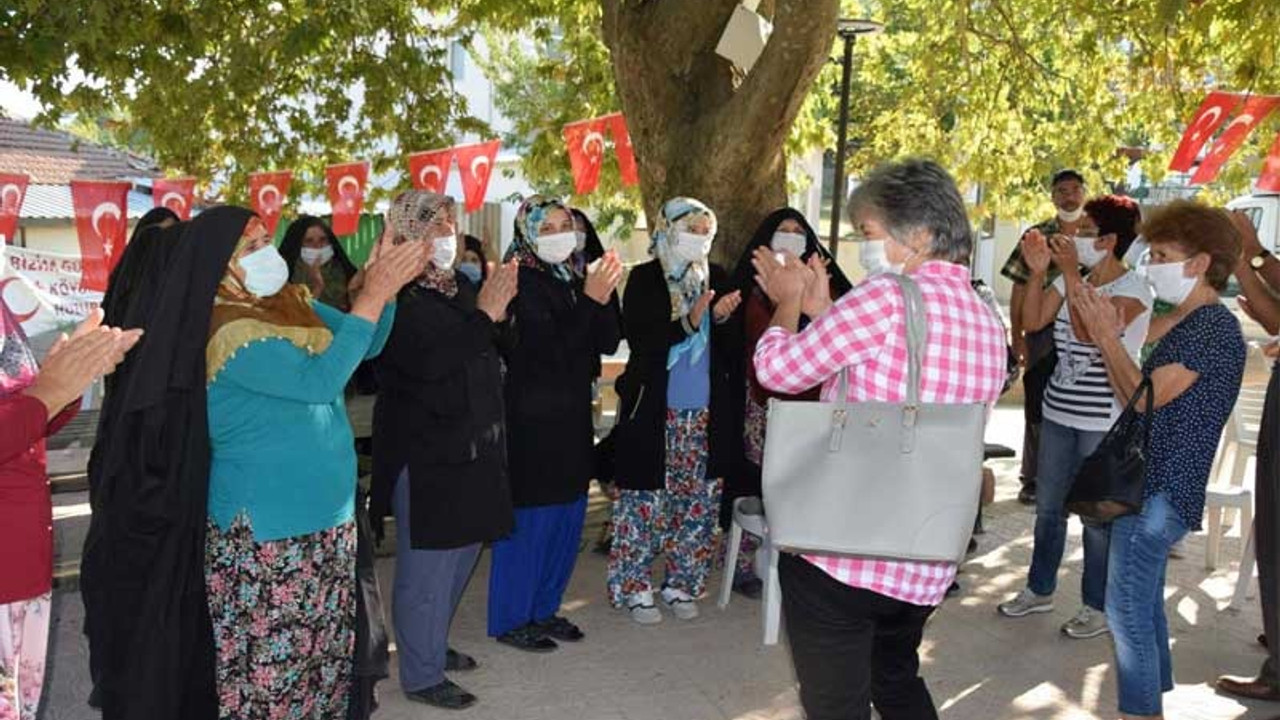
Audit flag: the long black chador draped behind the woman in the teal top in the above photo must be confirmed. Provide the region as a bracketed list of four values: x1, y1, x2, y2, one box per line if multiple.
[81, 206, 252, 720]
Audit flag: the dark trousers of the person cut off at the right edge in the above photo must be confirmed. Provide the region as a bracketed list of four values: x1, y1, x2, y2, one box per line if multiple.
[1240, 364, 1280, 689]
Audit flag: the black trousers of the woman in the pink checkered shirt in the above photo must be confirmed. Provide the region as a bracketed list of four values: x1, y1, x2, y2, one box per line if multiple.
[778, 553, 938, 720]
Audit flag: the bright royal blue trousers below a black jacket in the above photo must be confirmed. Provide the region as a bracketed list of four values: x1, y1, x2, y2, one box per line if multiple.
[489, 495, 586, 638]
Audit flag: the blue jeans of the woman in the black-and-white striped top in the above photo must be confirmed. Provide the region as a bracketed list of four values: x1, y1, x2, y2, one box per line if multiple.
[1027, 420, 1110, 611]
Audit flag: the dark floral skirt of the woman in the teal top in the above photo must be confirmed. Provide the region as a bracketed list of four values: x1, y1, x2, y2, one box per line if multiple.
[205, 514, 356, 720]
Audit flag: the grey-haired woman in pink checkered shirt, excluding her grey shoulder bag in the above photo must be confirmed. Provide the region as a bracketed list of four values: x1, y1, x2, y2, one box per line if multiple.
[755, 160, 1006, 720]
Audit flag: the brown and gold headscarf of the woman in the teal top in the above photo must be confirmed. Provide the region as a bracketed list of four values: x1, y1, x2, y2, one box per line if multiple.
[205, 217, 333, 384]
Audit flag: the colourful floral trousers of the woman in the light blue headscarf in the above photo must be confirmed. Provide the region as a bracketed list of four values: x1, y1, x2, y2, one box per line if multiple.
[608, 410, 722, 607]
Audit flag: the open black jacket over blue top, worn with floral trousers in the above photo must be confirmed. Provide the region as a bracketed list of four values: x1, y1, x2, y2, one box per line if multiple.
[613, 260, 745, 489]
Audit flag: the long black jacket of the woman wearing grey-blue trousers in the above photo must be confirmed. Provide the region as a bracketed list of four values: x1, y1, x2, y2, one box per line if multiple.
[370, 275, 515, 550]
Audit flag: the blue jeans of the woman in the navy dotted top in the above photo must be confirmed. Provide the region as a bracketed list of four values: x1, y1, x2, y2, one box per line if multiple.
[1107, 493, 1187, 715]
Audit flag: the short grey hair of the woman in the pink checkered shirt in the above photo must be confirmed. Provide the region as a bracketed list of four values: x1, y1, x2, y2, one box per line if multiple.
[849, 159, 973, 265]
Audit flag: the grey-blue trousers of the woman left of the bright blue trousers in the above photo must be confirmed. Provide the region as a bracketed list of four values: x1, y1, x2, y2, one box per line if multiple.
[392, 470, 480, 692]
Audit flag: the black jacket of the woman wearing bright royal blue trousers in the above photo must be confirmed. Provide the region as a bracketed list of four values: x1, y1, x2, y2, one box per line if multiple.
[506, 268, 621, 507]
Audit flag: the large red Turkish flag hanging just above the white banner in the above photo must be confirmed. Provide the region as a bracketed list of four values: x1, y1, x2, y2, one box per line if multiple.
[72, 181, 132, 291]
